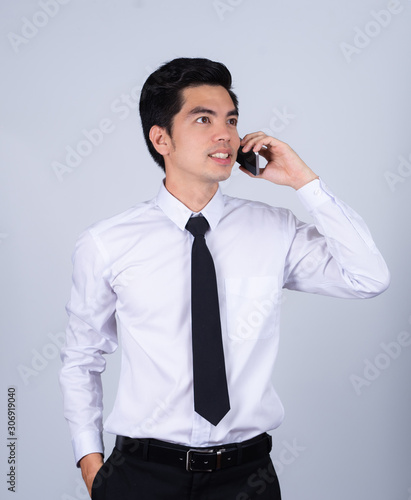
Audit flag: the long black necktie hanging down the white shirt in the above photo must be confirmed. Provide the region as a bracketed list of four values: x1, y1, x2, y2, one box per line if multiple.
[186, 216, 230, 425]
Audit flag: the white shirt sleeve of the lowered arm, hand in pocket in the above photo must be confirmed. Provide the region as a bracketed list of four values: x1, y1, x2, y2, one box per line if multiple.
[60, 231, 118, 465]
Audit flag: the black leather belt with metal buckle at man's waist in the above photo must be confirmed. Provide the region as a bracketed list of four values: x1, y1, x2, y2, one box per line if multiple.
[116, 433, 272, 472]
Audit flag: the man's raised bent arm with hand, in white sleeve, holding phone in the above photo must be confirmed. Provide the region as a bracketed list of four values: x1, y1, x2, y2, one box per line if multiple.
[241, 132, 390, 298]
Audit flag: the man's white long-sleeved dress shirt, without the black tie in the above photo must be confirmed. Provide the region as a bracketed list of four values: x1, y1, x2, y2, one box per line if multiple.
[60, 179, 389, 462]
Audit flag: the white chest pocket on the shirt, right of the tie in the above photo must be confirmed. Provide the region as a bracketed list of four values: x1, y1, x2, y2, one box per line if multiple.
[225, 276, 281, 341]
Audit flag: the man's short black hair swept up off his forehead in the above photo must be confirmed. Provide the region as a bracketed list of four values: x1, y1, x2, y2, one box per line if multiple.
[140, 57, 238, 170]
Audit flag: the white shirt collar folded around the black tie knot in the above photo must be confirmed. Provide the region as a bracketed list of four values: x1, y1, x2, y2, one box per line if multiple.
[155, 181, 224, 230]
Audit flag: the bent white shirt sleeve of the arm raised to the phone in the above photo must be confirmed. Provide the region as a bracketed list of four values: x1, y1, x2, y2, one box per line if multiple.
[283, 179, 390, 298]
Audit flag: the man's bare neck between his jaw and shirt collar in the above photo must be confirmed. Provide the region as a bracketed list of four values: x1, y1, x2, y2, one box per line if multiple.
[164, 176, 218, 212]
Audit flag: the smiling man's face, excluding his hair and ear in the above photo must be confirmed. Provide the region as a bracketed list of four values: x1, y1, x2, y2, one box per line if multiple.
[164, 85, 240, 188]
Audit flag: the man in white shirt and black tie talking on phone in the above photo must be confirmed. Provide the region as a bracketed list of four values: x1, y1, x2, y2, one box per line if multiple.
[61, 58, 389, 500]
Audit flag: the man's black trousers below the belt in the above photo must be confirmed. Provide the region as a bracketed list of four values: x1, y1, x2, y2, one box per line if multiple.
[92, 448, 281, 500]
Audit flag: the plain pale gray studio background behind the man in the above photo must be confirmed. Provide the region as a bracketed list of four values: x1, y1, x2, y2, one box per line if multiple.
[0, 0, 411, 500]
